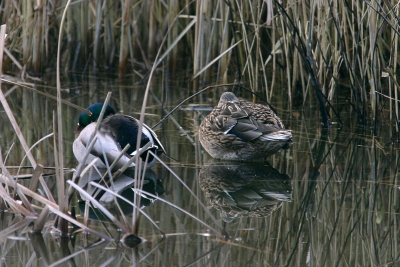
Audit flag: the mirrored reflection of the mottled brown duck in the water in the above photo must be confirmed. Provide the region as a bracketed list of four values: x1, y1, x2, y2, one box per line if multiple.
[199, 162, 292, 222]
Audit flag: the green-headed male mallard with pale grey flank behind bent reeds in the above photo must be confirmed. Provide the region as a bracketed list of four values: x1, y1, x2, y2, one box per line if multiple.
[73, 103, 165, 169]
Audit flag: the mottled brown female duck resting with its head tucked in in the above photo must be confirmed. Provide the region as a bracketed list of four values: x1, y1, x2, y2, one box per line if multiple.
[199, 92, 292, 161]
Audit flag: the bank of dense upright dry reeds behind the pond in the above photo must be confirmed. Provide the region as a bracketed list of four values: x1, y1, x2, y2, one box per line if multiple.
[0, 0, 399, 131]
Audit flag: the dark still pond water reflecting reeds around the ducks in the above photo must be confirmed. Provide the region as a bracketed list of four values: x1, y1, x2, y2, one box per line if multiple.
[0, 72, 400, 266]
